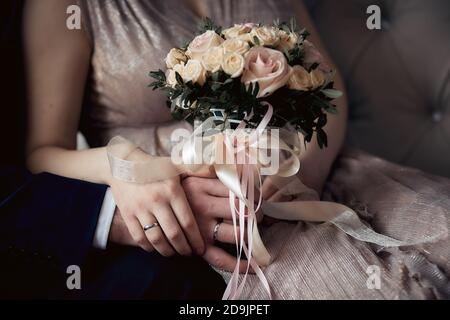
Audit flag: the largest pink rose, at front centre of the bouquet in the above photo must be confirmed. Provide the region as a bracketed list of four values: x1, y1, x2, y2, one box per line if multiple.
[241, 47, 291, 98]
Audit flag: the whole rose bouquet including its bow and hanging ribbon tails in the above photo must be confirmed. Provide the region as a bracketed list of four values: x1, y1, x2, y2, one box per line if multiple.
[145, 19, 341, 298]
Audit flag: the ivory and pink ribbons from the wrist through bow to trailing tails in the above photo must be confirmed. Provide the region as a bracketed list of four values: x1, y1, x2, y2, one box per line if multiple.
[107, 104, 436, 299]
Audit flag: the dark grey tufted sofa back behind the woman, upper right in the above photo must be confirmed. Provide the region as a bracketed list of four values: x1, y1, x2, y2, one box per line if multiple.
[310, 0, 450, 177]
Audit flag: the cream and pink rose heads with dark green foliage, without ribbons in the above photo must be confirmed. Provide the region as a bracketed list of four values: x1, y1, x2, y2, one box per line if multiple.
[150, 19, 341, 148]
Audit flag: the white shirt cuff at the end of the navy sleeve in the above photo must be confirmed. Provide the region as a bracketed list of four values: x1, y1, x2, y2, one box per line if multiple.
[93, 188, 116, 250]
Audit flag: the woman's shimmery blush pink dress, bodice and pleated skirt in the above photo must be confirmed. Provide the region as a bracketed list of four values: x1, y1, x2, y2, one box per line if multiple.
[79, 0, 450, 299]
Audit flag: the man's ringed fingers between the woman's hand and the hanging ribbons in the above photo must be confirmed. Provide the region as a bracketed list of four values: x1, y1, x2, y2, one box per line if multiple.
[182, 177, 253, 273]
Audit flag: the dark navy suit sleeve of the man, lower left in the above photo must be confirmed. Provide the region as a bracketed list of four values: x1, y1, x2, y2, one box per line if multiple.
[0, 170, 106, 278]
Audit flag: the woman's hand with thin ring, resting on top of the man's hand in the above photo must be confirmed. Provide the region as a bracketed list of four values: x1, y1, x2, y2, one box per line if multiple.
[110, 177, 205, 257]
